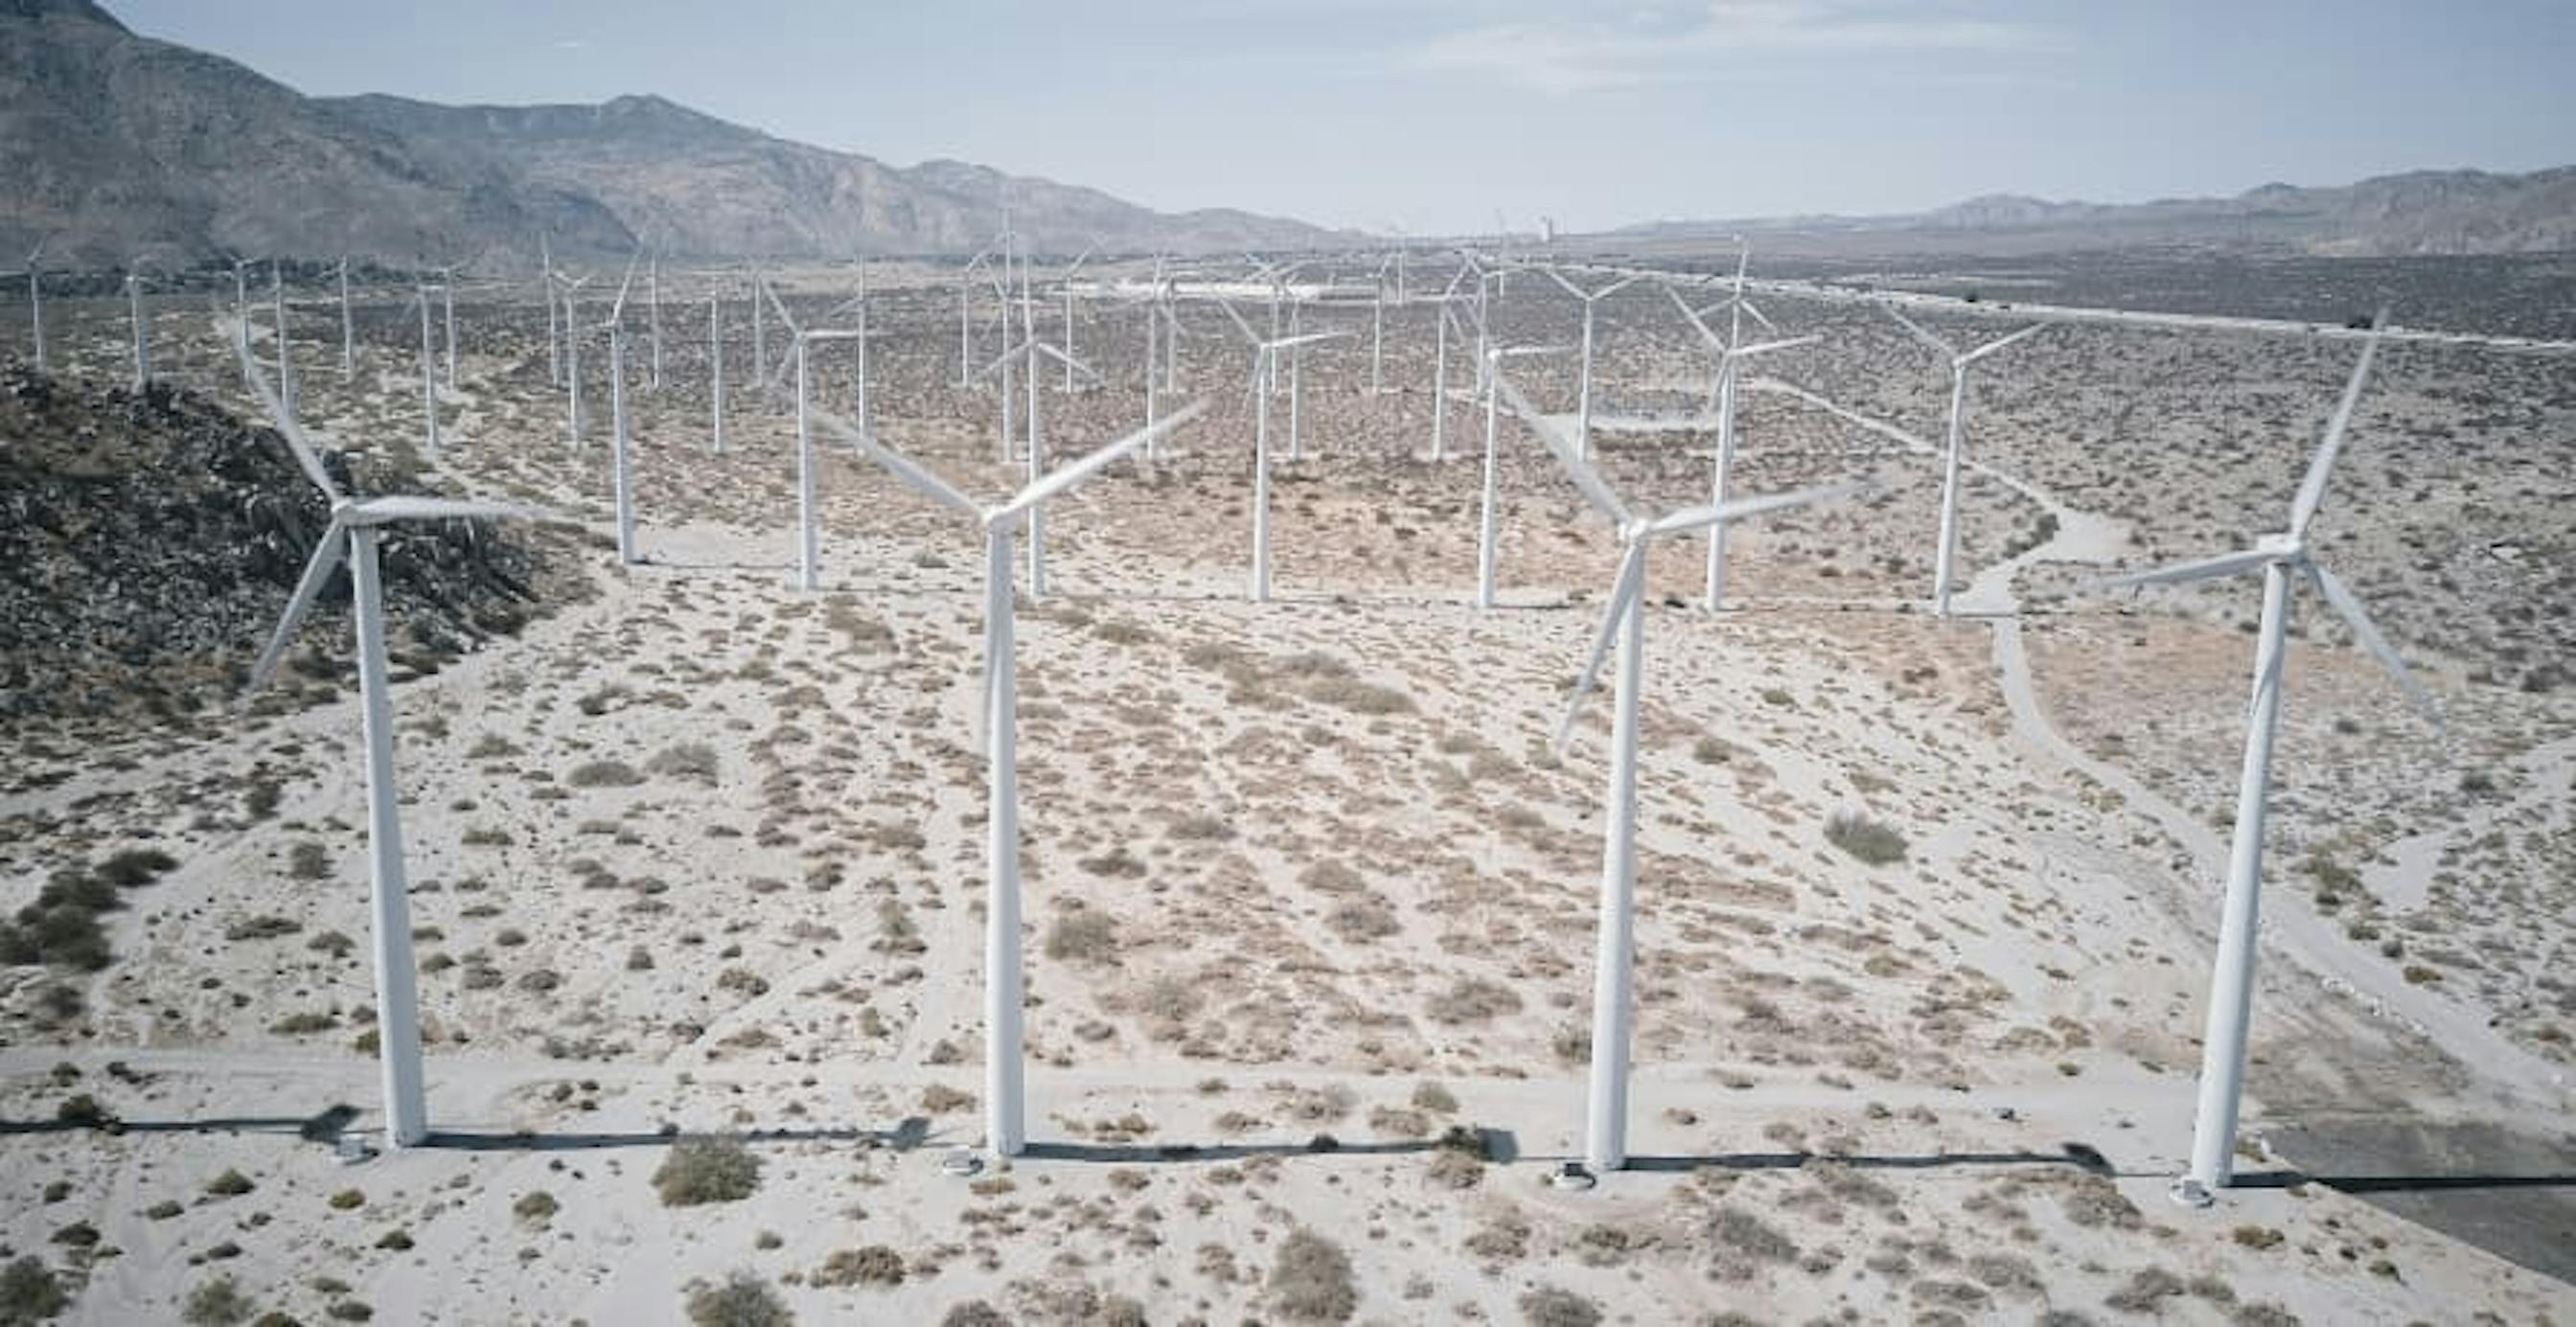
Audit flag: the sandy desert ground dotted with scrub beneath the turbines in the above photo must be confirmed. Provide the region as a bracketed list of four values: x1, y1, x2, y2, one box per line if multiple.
[0, 261, 2576, 1324]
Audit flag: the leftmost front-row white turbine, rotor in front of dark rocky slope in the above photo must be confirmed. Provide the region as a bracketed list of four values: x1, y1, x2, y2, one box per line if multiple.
[235, 334, 536, 1147]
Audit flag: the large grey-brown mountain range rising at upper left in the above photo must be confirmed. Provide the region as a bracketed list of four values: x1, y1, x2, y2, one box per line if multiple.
[0, 0, 1350, 265]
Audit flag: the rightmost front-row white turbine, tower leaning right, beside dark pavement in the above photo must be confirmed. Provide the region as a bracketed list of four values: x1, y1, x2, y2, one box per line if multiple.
[2079, 319, 2442, 1206]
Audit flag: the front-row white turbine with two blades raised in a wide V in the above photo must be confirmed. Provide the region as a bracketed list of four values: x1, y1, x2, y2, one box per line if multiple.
[816, 402, 1201, 1162]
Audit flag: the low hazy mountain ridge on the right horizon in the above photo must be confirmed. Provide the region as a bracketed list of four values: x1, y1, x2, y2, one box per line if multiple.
[1615, 168, 2576, 255]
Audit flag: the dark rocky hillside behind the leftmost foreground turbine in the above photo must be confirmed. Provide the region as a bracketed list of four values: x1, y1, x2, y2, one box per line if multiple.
[0, 366, 551, 724]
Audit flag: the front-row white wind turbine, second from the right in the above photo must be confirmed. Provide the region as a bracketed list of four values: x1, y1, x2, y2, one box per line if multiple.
[1494, 374, 1868, 1178]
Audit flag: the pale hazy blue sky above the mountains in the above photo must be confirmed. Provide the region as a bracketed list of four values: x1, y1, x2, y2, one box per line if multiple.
[108, 0, 2576, 235]
